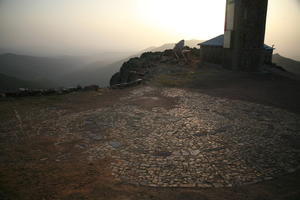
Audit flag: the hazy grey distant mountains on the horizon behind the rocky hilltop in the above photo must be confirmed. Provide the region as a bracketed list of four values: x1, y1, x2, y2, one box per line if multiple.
[0, 40, 300, 90]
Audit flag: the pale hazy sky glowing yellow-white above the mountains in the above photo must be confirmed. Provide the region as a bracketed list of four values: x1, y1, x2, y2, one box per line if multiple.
[0, 0, 300, 60]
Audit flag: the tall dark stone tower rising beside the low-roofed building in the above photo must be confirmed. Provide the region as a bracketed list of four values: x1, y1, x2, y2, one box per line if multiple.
[223, 0, 268, 71]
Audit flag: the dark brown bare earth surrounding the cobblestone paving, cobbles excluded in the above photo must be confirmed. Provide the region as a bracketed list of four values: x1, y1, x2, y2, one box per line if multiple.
[0, 63, 300, 200]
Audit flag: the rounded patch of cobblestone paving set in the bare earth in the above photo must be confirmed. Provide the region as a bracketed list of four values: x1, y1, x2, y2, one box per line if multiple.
[52, 86, 300, 188]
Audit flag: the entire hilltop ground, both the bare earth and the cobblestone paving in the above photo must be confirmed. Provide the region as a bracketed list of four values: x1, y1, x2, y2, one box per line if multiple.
[0, 63, 300, 200]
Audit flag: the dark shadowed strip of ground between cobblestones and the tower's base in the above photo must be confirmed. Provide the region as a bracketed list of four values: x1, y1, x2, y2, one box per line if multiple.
[187, 72, 300, 114]
